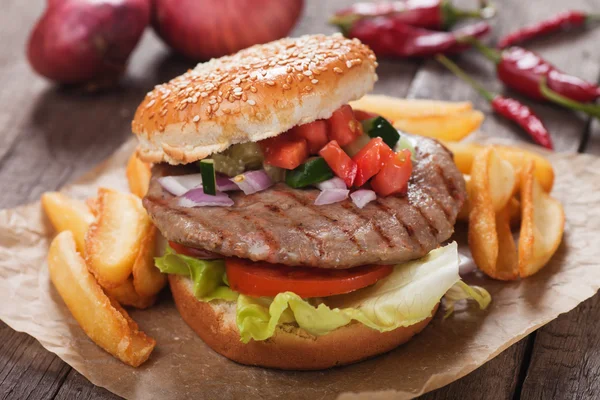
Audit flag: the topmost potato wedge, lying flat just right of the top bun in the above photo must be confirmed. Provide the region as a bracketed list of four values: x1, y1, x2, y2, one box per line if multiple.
[350, 94, 473, 121]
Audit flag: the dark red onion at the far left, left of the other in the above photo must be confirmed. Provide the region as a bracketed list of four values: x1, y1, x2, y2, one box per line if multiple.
[27, 0, 151, 84]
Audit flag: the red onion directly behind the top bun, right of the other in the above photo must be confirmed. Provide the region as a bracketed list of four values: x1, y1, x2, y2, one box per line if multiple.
[152, 0, 304, 61]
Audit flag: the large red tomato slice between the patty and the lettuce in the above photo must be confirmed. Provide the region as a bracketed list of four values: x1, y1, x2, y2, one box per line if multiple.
[225, 258, 394, 298]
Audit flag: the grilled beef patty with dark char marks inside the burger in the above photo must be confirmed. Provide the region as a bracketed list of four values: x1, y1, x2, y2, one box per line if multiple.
[144, 137, 466, 268]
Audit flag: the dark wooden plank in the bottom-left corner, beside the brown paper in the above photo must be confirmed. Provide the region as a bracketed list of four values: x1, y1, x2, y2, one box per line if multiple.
[0, 322, 71, 399]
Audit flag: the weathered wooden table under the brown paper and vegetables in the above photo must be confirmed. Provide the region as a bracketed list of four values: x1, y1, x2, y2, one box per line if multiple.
[0, 0, 600, 399]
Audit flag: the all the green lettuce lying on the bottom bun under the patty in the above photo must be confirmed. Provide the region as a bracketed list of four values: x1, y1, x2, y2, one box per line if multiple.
[156, 243, 491, 343]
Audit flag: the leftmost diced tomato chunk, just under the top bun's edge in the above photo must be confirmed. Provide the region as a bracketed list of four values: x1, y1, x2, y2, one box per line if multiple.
[259, 132, 308, 169]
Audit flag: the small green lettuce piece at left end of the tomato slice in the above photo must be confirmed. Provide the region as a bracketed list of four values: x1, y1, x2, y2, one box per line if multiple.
[154, 246, 238, 301]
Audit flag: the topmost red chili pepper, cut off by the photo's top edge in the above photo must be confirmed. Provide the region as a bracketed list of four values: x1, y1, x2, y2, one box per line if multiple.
[329, 0, 495, 31]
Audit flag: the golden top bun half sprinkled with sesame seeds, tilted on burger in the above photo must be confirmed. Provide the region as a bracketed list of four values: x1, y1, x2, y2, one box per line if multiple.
[132, 35, 377, 164]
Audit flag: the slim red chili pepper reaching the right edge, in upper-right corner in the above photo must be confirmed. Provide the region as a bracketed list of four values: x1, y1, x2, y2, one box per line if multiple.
[498, 11, 600, 49]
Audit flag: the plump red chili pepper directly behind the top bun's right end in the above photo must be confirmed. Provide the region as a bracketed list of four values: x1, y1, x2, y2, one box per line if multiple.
[347, 17, 490, 57]
